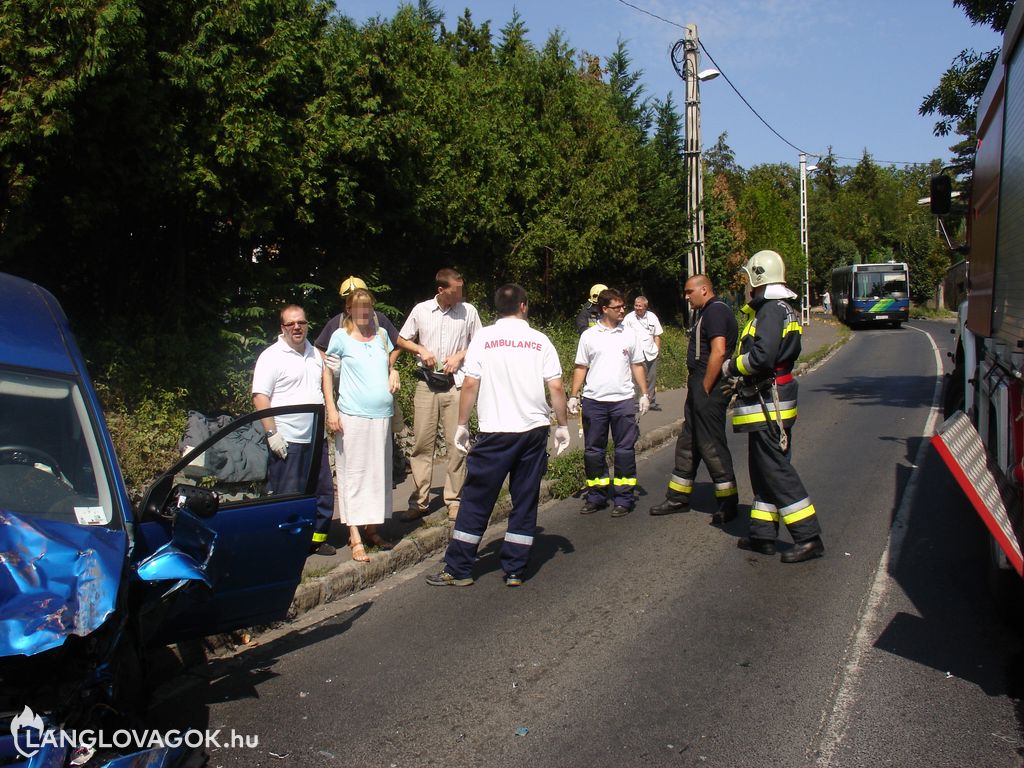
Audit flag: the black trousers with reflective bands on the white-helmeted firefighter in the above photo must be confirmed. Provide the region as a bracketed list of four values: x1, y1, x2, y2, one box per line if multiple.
[748, 429, 821, 543]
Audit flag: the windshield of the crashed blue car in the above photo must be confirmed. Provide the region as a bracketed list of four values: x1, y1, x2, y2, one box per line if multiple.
[0, 369, 120, 526]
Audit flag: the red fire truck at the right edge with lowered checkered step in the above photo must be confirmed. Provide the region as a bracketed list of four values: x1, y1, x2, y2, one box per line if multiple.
[931, 3, 1024, 594]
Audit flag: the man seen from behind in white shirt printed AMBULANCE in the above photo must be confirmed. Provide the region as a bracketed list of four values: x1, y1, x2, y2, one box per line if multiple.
[427, 283, 569, 587]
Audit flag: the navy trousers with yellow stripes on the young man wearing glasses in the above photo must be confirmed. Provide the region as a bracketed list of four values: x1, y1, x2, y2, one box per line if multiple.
[583, 397, 640, 509]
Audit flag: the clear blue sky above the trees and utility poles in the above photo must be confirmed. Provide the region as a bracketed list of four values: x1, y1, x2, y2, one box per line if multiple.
[337, 0, 999, 168]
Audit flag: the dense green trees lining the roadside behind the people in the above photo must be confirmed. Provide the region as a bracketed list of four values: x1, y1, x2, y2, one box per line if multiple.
[0, 0, 958, 482]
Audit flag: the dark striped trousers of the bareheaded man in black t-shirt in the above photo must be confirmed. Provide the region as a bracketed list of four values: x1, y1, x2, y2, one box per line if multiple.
[666, 371, 739, 511]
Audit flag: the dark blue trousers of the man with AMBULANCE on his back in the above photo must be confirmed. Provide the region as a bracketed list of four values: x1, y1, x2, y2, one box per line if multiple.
[444, 427, 549, 579]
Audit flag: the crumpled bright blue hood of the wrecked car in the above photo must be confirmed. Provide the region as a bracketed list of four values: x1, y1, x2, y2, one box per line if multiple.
[0, 510, 128, 655]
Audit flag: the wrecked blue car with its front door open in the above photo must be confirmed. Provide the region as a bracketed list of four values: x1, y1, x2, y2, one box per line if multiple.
[0, 273, 324, 766]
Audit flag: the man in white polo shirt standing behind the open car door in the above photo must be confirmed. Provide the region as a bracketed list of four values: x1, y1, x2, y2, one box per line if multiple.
[253, 304, 335, 555]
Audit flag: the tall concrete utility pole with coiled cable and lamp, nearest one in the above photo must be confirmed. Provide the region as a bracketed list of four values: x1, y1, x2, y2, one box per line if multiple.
[672, 24, 721, 286]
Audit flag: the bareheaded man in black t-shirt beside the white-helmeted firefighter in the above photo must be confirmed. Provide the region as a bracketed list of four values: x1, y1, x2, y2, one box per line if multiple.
[650, 274, 739, 524]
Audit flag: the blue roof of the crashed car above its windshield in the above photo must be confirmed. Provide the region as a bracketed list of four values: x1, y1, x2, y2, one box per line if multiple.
[0, 272, 78, 374]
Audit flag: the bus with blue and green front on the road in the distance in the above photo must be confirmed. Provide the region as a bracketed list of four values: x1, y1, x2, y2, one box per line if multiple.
[831, 261, 910, 328]
